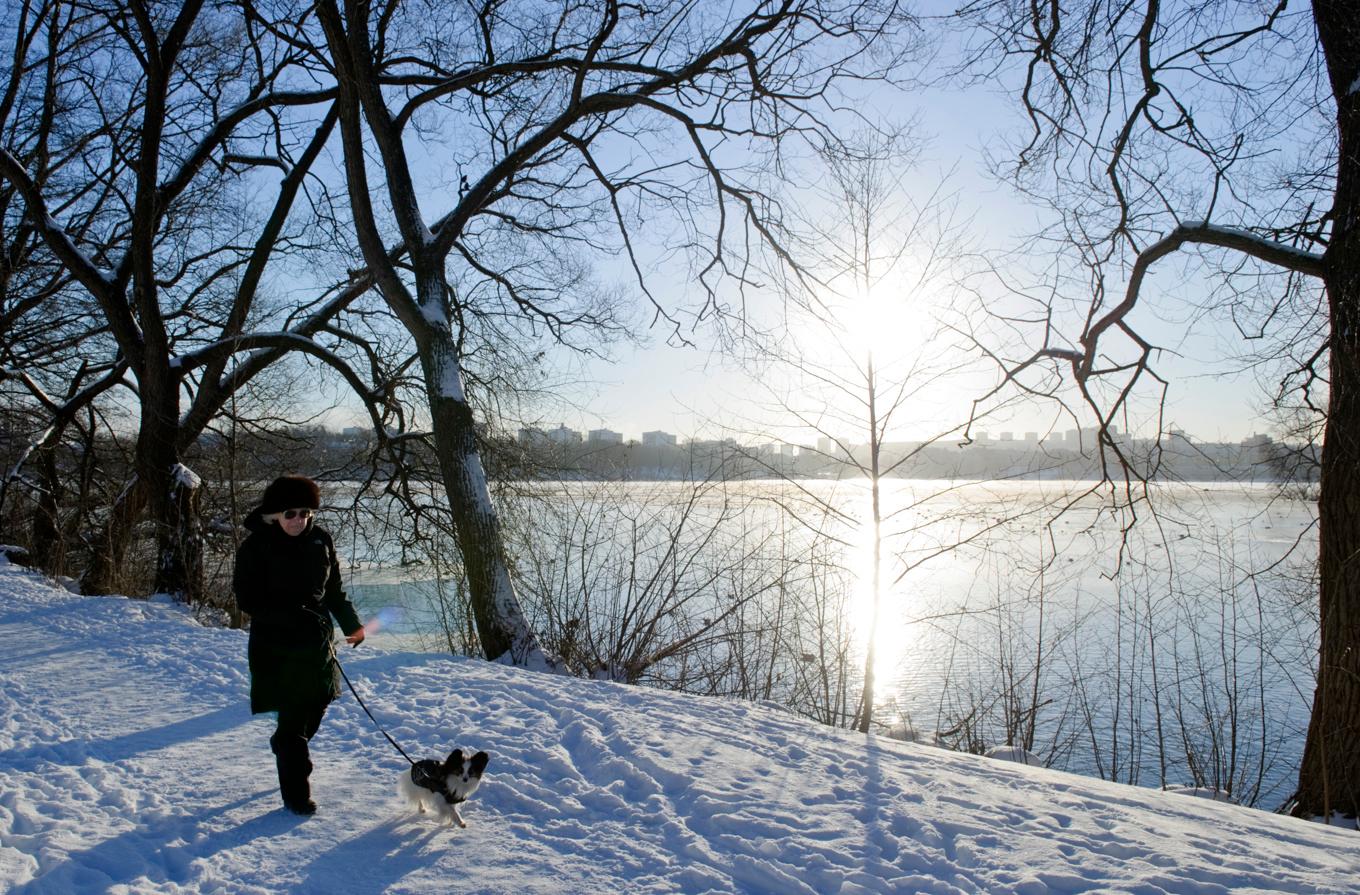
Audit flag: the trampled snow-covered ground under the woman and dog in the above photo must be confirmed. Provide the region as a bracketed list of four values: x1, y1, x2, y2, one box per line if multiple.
[0, 566, 1360, 895]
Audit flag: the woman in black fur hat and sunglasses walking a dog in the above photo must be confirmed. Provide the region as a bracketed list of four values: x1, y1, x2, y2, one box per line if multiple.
[233, 476, 363, 815]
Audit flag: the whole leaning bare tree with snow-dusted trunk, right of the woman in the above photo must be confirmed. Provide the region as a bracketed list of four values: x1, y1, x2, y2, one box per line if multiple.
[317, 0, 900, 664]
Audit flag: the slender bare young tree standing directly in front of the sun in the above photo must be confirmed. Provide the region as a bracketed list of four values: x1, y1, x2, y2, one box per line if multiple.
[739, 131, 1055, 732]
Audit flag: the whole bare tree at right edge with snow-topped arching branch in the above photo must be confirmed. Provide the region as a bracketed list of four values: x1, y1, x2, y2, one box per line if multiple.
[959, 0, 1360, 817]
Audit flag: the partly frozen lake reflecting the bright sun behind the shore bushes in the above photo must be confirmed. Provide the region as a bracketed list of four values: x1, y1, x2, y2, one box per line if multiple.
[337, 480, 1316, 808]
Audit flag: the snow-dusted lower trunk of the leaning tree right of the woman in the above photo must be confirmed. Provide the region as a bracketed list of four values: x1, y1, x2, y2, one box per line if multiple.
[420, 314, 551, 669]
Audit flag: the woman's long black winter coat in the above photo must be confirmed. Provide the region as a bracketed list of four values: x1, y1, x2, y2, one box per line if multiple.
[233, 510, 362, 713]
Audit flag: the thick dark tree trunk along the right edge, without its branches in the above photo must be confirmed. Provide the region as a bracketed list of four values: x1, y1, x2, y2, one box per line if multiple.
[1293, 0, 1360, 817]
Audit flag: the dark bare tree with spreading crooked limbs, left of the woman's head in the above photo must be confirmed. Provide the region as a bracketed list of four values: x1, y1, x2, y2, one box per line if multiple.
[0, 0, 394, 598]
